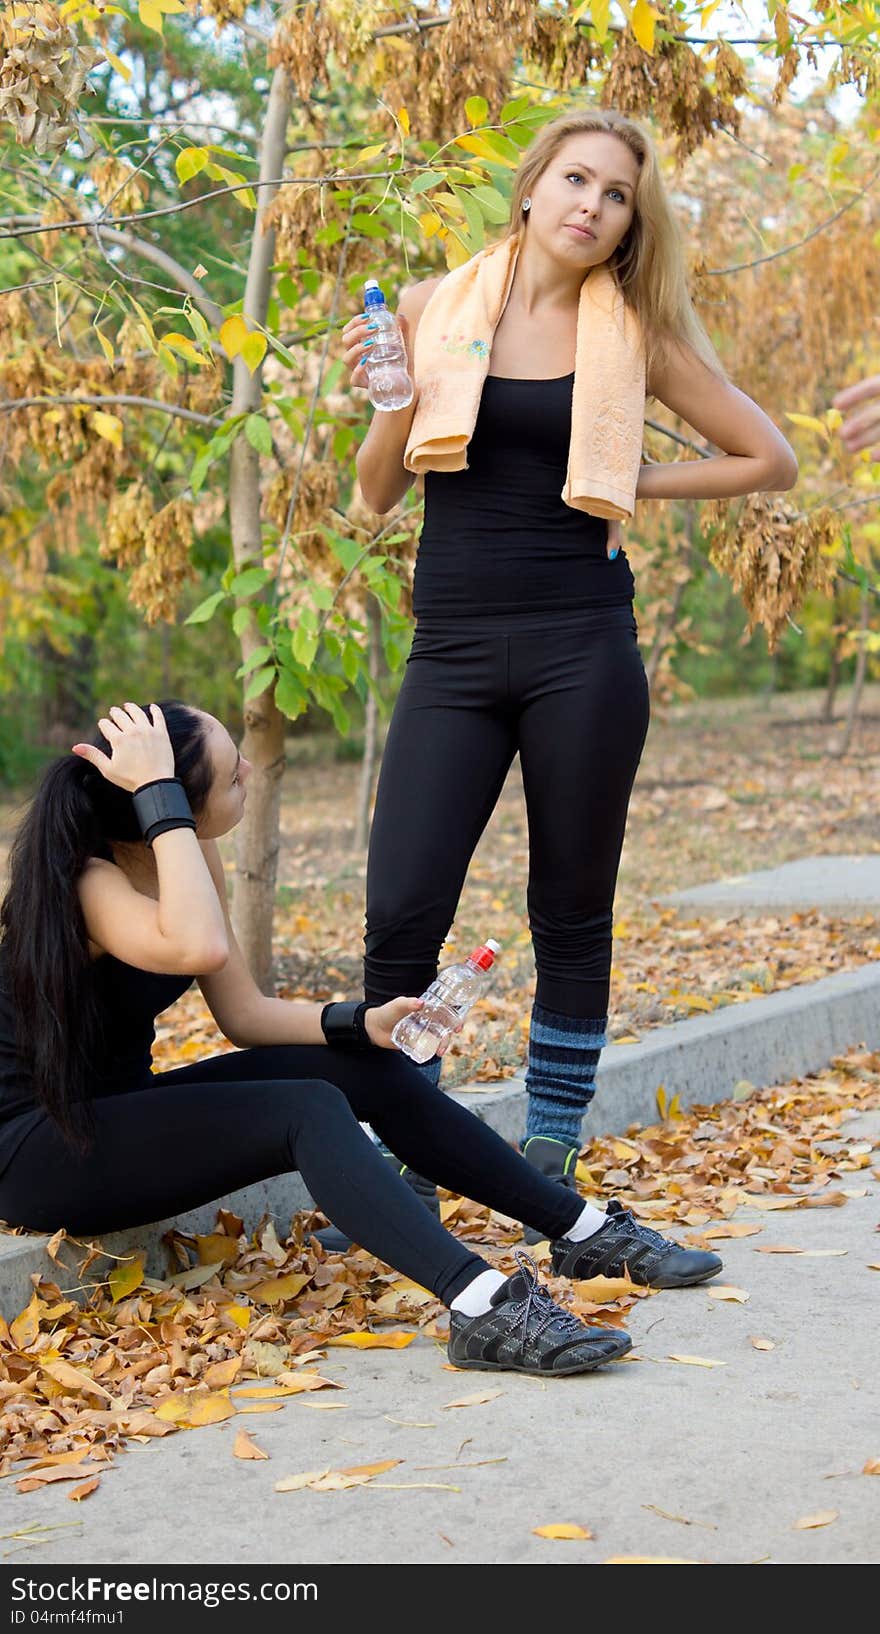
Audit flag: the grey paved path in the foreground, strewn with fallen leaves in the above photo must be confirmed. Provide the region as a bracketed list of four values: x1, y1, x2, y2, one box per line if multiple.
[0, 1113, 880, 1569]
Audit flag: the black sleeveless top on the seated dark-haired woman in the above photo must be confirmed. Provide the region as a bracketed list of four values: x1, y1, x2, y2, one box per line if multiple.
[0, 948, 193, 1173]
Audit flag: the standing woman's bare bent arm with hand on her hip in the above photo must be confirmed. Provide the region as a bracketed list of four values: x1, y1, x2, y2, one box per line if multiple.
[637, 336, 797, 500]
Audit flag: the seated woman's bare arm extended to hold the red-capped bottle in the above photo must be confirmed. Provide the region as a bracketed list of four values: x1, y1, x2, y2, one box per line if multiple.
[199, 840, 420, 1049]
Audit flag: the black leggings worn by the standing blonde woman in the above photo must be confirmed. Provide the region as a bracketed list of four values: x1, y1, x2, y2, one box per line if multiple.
[364, 606, 648, 1018]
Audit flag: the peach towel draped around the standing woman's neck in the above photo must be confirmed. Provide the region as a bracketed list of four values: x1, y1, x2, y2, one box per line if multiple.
[403, 234, 645, 521]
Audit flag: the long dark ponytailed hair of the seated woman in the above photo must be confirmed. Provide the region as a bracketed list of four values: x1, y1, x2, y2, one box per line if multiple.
[0, 699, 212, 1149]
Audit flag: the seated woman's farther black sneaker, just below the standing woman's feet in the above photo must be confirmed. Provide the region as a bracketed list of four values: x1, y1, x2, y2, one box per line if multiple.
[550, 1199, 722, 1288]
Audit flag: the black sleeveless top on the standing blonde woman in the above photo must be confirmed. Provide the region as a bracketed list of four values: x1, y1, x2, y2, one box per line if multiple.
[413, 374, 635, 618]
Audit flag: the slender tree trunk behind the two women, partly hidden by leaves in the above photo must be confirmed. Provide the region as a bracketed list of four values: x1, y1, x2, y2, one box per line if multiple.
[229, 69, 291, 993]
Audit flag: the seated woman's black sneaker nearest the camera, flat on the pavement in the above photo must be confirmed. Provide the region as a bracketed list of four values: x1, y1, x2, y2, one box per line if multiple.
[447, 1252, 632, 1376]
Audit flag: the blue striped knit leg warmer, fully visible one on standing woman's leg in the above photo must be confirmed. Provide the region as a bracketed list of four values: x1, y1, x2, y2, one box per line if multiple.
[526, 1003, 607, 1145]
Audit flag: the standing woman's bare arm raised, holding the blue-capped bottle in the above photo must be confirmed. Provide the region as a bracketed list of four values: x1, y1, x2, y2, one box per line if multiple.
[352, 278, 441, 516]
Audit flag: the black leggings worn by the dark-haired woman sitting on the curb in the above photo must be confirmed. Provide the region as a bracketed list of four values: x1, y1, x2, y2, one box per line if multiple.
[0, 1044, 583, 1304]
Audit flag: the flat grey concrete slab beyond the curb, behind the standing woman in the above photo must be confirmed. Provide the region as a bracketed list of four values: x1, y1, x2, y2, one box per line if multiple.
[664, 853, 880, 917]
